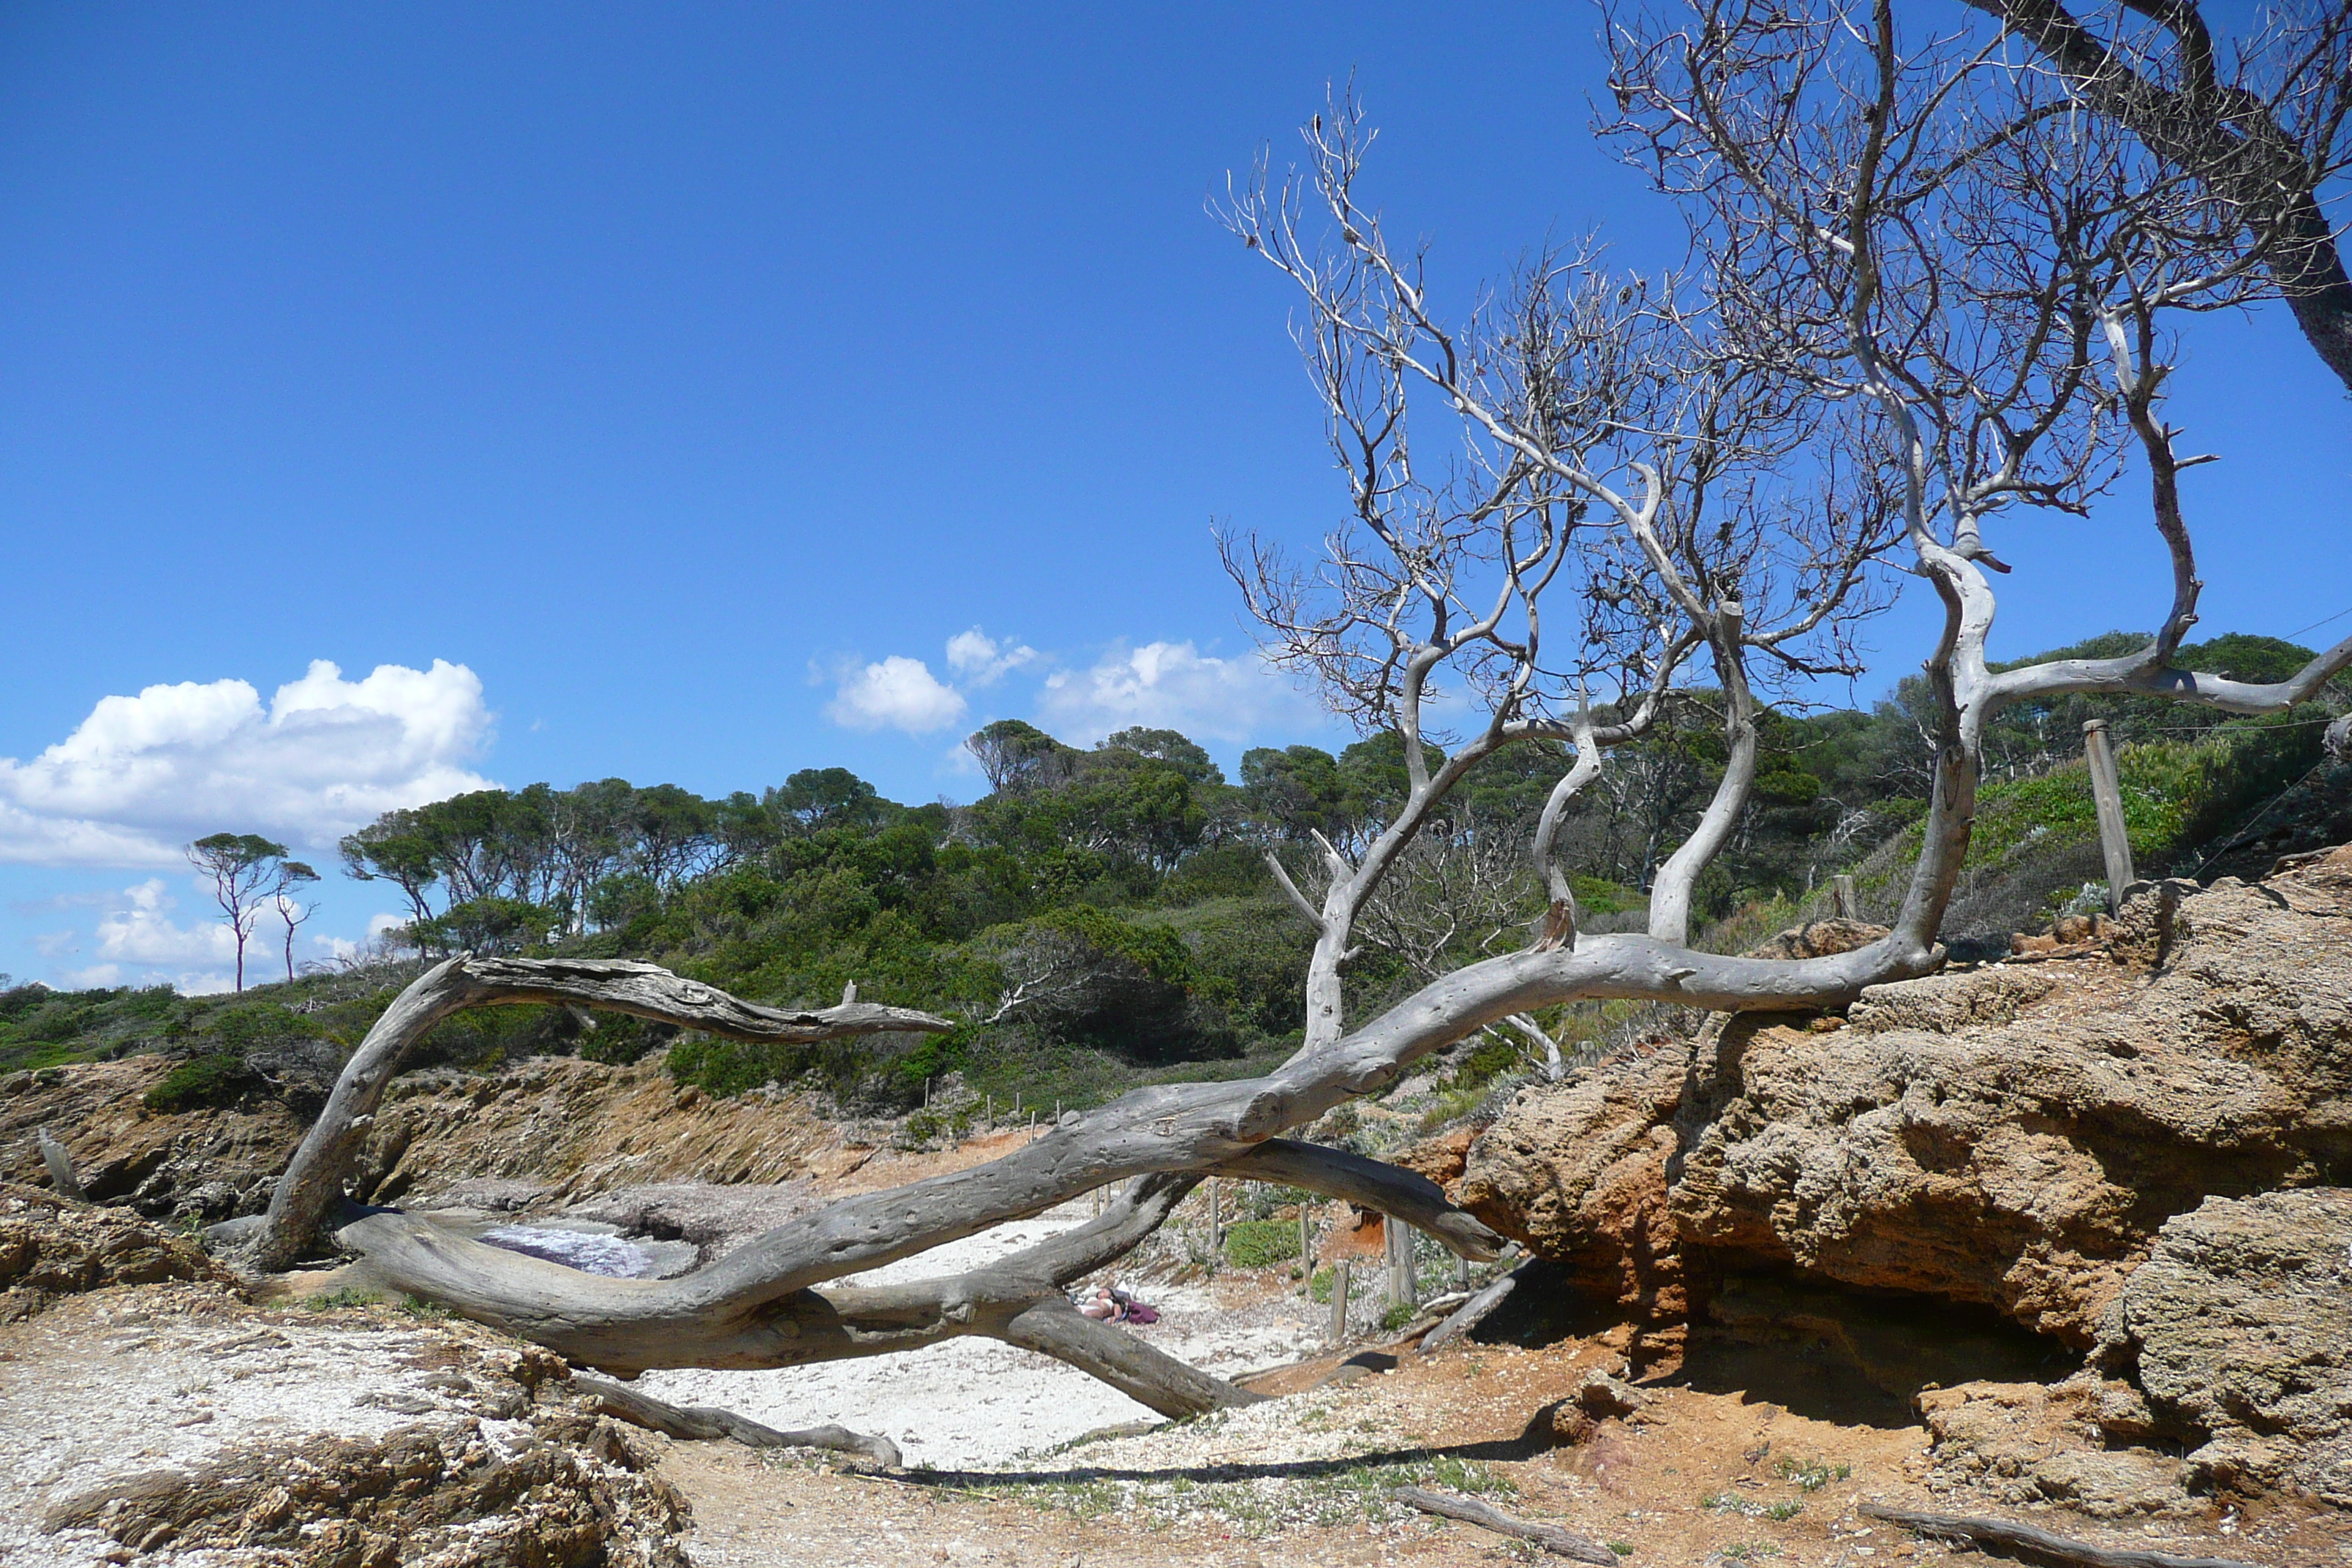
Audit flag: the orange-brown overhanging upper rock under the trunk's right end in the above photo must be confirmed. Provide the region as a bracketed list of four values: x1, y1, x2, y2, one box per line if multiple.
[1460, 848, 2352, 1349]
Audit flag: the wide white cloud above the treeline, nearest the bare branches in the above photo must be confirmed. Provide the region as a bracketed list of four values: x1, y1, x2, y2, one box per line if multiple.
[1039, 642, 1319, 741]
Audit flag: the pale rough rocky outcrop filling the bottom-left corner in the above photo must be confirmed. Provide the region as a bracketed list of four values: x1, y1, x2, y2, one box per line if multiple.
[0, 1189, 689, 1568]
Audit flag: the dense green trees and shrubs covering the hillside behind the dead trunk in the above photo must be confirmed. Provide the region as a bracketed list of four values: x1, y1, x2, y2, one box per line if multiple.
[0, 633, 2352, 1114]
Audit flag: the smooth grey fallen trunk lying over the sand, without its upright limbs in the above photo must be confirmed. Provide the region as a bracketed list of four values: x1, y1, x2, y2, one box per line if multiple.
[294, 935, 1931, 1415]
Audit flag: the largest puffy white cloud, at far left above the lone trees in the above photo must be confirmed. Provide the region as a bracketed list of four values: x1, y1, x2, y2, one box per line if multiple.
[0, 658, 491, 867]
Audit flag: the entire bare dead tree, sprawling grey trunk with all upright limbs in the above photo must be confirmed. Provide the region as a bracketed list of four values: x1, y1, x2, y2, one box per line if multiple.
[207, 0, 2352, 1415]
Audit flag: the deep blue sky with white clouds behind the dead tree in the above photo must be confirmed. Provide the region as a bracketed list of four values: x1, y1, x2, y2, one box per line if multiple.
[0, 4, 2352, 985]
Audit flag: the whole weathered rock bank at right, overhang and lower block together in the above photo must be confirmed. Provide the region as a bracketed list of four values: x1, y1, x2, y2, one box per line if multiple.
[1456, 846, 2352, 1502]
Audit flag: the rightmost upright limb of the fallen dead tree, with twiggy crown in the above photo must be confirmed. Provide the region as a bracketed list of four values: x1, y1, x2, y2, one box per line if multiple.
[1609, 0, 2352, 945]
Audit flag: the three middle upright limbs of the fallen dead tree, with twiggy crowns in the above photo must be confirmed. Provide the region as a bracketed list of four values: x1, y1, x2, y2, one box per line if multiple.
[1223, 99, 1898, 982]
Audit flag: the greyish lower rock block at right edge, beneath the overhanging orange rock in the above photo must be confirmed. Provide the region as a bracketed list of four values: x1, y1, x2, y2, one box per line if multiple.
[2103, 1187, 2352, 1507]
